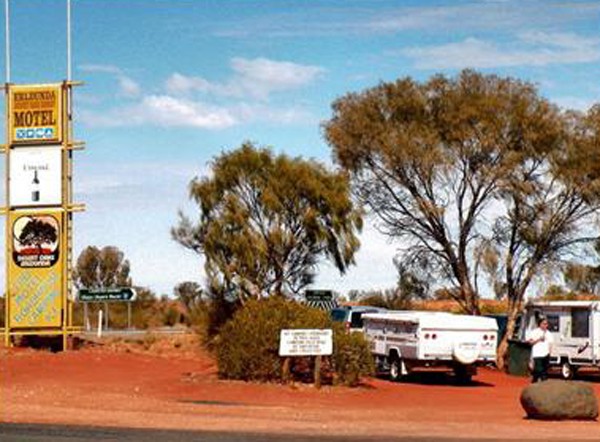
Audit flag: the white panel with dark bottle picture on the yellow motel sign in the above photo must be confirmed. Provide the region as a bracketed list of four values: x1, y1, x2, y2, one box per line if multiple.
[9, 147, 62, 207]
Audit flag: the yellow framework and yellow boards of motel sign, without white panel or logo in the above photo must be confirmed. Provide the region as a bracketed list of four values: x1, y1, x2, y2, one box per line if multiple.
[2, 81, 84, 350]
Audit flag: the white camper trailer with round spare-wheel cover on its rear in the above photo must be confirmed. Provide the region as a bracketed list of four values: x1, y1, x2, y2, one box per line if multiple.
[363, 311, 498, 382]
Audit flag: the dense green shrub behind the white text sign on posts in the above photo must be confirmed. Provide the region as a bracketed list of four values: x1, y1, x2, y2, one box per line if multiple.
[215, 297, 373, 385]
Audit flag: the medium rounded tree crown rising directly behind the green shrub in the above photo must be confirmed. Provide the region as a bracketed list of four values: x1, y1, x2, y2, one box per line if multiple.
[172, 143, 362, 303]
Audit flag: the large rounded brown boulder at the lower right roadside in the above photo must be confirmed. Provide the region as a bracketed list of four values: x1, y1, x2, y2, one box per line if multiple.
[521, 380, 598, 420]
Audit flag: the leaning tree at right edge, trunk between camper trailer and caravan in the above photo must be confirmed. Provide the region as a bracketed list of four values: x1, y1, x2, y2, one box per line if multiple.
[491, 107, 600, 365]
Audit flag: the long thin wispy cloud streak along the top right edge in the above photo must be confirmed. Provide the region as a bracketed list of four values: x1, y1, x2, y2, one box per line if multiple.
[211, 0, 600, 39]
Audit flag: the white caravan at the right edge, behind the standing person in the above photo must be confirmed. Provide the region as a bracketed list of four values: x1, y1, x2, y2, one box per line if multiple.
[518, 301, 600, 379]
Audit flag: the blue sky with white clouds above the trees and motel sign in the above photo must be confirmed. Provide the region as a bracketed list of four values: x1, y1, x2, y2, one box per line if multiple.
[0, 0, 600, 295]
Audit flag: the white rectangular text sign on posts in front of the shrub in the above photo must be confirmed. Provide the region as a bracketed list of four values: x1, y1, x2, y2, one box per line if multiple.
[279, 329, 333, 356]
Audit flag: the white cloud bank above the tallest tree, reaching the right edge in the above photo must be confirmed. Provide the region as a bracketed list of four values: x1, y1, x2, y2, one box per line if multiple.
[401, 32, 600, 69]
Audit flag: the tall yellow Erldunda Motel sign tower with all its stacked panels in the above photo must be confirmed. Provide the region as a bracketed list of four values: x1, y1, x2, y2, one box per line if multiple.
[4, 81, 83, 348]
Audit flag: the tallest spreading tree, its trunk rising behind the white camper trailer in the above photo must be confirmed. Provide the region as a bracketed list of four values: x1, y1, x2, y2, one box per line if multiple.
[325, 71, 558, 313]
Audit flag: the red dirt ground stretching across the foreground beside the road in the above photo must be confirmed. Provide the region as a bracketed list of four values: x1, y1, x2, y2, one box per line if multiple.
[0, 338, 600, 440]
